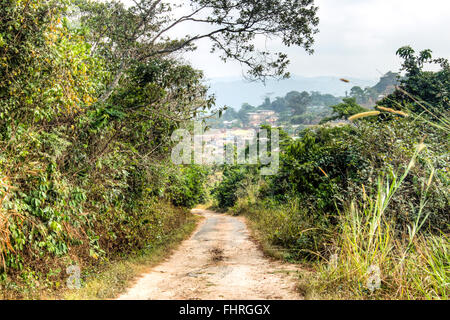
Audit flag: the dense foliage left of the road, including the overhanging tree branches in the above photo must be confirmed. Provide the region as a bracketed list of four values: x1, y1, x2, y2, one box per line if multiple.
[0, 0, 324, 293]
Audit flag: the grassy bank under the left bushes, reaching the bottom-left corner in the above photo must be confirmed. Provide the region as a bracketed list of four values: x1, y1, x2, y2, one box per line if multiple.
[0, 203, 199, 300]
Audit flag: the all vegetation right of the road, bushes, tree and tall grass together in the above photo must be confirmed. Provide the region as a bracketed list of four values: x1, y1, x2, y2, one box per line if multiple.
[213, 49, 450, 299]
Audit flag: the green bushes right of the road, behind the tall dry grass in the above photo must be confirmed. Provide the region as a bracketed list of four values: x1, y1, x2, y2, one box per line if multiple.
[223, 114, 450, 259]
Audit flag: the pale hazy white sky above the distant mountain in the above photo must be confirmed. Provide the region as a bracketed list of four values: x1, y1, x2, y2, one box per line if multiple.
[123, 0, 450, 79]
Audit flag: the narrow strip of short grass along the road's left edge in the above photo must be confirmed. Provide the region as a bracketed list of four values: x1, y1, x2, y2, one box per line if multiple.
[48, 215, 202, 300]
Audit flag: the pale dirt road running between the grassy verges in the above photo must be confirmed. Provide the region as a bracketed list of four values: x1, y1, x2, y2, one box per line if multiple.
[119, 209, 301, 300]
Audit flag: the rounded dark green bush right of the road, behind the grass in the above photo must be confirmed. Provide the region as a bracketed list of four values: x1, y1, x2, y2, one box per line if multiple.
[264, 126, 363, 210]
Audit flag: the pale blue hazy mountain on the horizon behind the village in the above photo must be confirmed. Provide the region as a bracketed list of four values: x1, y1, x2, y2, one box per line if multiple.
[209, 76, 378, 110]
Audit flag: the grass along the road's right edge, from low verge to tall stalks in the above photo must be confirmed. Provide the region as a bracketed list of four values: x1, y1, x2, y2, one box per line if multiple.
[229, 144, 450, 300]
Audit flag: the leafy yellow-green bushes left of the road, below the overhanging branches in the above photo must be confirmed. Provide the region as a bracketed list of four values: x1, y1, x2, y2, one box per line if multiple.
[0, 0, 212, 294]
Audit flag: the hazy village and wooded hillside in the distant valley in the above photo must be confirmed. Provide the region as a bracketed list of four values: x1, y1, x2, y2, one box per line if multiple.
[207, 72, 399, 141]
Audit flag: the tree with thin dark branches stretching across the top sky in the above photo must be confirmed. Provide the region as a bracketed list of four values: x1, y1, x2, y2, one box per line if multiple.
[75, 0, 319, 101]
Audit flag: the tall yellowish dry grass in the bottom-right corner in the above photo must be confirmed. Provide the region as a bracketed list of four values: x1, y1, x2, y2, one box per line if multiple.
[309, 145, 450, 300]
